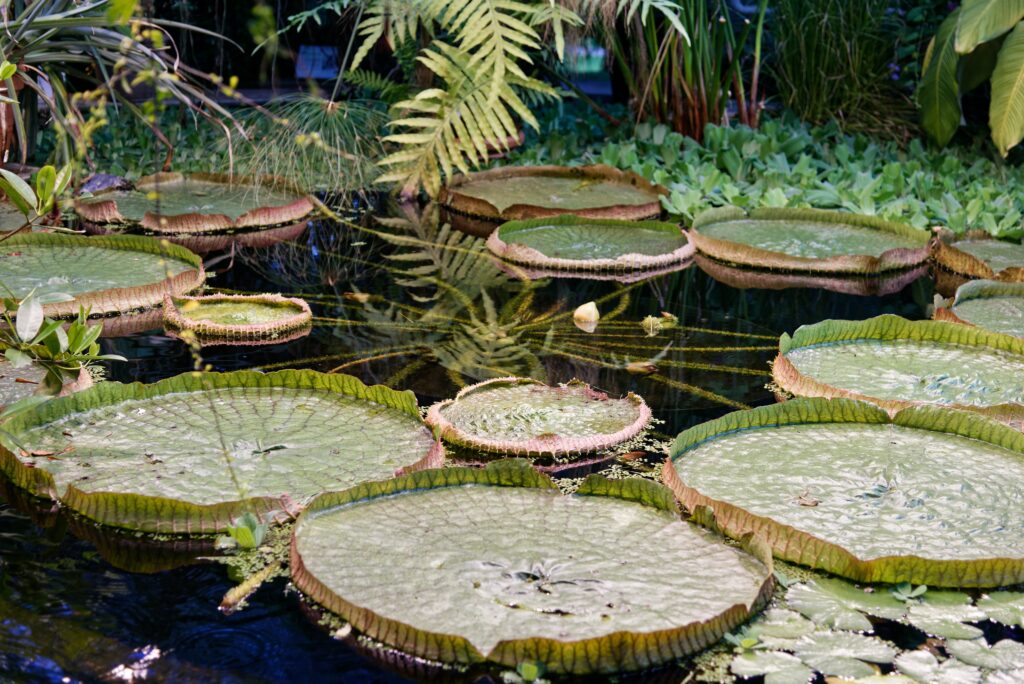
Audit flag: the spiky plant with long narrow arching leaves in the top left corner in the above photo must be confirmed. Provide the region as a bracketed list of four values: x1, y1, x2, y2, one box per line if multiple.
[0, 0, 231, 166]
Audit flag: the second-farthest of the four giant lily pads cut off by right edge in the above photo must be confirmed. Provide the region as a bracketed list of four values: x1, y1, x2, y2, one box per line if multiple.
[934, 281, 1024, 337]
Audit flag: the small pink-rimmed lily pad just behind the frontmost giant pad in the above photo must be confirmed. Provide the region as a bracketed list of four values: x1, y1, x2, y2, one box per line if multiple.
[427, 378, 650, 456]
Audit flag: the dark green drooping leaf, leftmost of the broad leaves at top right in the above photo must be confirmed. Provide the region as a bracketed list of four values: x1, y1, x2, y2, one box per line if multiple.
[918, 10, 961, 145]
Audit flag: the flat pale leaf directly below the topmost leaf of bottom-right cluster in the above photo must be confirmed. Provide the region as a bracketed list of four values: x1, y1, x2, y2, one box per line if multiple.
[794, 632, 898, 679]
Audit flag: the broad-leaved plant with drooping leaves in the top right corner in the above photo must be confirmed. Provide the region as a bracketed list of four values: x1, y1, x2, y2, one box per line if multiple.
[918, 0, 1024, 157]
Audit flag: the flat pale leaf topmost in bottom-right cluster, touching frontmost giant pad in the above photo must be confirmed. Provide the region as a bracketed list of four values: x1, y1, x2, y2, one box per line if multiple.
[785, 578, 906, 632]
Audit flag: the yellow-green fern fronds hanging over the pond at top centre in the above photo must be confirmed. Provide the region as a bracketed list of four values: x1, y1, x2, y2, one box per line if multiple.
[290, 0, 700, 195]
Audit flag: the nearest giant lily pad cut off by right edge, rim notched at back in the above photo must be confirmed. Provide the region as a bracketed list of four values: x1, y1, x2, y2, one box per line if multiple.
[663, 399, 1024, 587]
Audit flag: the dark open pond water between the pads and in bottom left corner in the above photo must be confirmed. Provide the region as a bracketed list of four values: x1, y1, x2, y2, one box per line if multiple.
[0, 209, 932, 682]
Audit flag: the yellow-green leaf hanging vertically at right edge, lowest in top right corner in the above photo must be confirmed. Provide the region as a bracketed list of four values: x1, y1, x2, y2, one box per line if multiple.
[988, 23, 1024, 157]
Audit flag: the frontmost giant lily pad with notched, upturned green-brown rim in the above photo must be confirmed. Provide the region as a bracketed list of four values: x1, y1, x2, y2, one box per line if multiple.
[291, 462, 772, 674]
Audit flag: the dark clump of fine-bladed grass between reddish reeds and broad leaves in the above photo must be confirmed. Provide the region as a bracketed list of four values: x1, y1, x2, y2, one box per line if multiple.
[769, 0, 913, 134]
